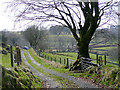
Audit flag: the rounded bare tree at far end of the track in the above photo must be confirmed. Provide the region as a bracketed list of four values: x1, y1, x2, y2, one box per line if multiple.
[22, 25, 46, 50]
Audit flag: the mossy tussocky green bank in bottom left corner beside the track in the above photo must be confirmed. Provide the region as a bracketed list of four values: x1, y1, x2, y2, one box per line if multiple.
[2, 66, 42, 89]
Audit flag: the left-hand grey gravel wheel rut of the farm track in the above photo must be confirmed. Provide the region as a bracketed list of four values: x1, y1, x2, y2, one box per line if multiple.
[21, 51, 62, 88]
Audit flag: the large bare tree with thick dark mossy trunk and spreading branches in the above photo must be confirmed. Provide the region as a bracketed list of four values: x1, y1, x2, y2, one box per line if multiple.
[9, 0, 119, 69]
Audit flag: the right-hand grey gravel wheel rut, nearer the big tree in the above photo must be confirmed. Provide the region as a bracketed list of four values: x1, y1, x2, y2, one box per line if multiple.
[27, 51, 98, 88]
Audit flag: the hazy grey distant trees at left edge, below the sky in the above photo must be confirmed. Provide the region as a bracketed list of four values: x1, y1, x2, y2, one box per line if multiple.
[0, 30, 29, 46]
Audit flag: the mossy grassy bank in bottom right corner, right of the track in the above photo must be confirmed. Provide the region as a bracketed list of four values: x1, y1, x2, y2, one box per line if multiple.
[80, 65, 120, 88]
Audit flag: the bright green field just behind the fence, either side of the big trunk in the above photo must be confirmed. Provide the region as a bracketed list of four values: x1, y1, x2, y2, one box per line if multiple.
[42, 52, 117, 67]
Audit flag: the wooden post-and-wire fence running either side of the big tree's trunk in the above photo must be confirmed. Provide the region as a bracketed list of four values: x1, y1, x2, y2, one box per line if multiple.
[37, 53, 119, 66]
